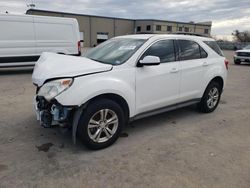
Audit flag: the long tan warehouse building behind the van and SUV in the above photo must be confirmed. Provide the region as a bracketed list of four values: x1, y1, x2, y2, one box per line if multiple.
[26, 9, 212, 47]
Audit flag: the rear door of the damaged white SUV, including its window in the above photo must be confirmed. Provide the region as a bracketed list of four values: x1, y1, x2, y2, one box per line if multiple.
[178, 40, 209, 102]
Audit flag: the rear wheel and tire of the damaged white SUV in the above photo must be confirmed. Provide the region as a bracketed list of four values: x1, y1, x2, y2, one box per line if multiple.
[198, 81, 222, 113]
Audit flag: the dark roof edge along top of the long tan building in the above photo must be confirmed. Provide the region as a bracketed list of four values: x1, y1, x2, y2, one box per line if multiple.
[26, 9, 212, 27]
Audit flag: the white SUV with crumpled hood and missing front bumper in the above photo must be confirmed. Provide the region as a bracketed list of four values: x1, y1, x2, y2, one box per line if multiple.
[32, 35, 228, 149]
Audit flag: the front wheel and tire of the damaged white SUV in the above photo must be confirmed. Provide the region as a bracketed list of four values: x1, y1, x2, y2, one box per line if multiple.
[77, 99, 125, 150]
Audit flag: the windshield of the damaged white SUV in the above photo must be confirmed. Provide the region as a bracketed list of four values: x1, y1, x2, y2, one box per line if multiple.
[85, 38, 146, 65]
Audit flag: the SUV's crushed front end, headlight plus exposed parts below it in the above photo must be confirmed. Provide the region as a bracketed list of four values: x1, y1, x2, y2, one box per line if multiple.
[34, 78, 75, 128]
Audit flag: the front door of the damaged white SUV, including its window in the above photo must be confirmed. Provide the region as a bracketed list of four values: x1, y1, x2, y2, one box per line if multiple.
[136, 40, 180, 114]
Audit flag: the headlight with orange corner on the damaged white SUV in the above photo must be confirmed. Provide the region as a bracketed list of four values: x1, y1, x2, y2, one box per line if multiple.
[37, 78, 73, 101]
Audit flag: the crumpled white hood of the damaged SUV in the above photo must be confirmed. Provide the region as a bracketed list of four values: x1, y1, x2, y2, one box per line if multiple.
[32, 52, 112, 86]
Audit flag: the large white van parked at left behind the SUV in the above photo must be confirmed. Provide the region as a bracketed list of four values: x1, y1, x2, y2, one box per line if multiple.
[0, 14, 81, 67]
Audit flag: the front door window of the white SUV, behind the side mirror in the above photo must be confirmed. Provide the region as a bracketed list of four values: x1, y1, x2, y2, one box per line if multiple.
[141, 40, 176, 63]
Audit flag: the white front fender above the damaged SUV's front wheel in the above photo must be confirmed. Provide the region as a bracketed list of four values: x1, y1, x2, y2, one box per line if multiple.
[56, 72, 135, 116]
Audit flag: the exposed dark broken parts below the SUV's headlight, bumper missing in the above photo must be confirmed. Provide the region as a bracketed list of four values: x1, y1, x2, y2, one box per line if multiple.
[34, 96, 75, 128]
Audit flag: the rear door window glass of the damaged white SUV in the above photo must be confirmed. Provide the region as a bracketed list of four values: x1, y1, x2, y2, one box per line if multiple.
[179, 40, 202, 60]
